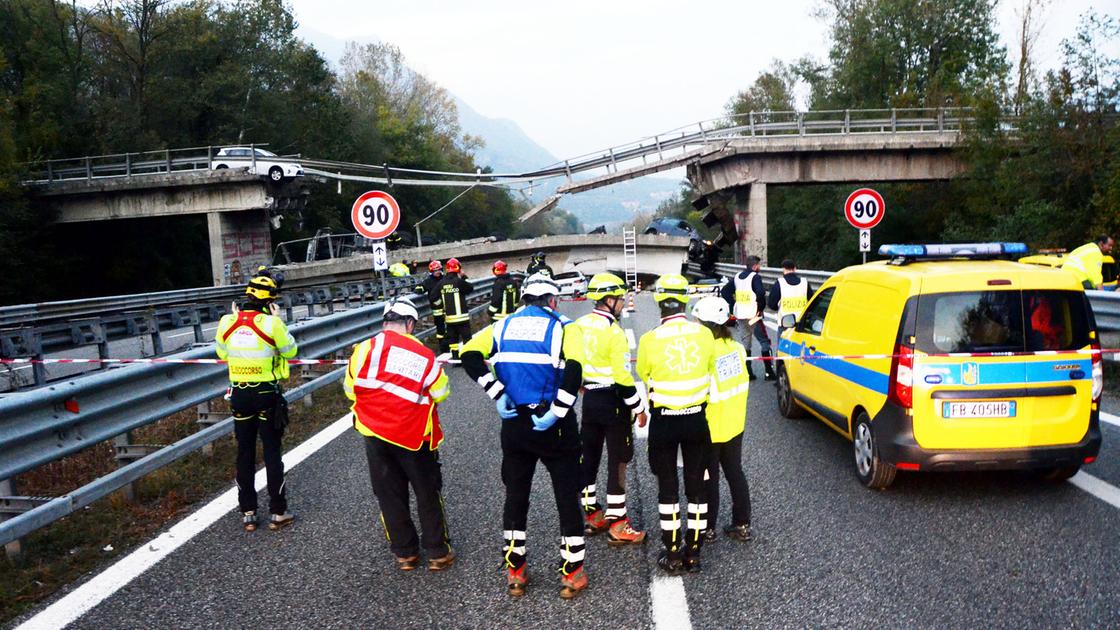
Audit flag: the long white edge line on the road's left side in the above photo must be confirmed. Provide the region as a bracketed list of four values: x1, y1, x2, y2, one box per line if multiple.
[17, 414, 353, 630]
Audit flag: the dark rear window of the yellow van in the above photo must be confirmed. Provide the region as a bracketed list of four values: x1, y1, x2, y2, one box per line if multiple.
[915, 290, 1090, 353]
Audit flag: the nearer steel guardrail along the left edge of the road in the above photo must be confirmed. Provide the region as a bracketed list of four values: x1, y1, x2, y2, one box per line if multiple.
[0, 277, 494, 544]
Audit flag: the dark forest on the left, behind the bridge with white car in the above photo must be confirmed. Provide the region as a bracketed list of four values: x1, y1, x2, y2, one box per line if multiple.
[0, 0, 579, 304]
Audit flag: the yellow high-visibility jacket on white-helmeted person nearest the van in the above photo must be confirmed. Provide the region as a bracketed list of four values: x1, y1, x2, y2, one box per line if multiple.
[706, 339, 750, 443]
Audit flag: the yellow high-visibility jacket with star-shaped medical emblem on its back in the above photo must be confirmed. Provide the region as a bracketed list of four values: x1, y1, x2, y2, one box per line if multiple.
[637, 315, 713, 409]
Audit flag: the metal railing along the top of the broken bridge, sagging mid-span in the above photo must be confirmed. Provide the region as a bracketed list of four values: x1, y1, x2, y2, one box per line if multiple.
[25, 108, 994, 185]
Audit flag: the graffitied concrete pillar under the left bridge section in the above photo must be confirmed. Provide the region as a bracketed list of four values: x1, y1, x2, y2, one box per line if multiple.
[206, 210, 272, 287]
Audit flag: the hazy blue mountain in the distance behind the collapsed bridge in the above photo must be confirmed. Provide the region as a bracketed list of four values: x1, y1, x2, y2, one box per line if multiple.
[455, 98, 680, 229]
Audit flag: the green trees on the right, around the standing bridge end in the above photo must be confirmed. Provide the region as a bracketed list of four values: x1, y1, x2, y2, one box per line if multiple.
[659, 0, 1120, 270]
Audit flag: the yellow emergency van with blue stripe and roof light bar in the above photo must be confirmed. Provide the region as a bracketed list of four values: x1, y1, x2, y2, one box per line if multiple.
[777, 243, 1103, 489]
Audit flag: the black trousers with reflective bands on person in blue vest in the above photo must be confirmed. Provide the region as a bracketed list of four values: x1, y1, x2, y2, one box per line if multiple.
[502, 409, 584, 574]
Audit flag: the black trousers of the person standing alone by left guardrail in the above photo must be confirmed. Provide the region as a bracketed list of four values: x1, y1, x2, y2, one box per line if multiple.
[230, 382, 288, 515]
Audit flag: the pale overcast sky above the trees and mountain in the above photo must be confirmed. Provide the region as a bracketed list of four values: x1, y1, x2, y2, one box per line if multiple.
[290, 0, 1120, 158]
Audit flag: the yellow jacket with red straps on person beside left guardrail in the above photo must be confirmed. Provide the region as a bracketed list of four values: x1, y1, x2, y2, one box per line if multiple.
[214, 311, 298, 382]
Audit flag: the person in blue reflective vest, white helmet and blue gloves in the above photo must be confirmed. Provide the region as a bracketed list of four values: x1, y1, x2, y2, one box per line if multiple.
[461, 274, 588, 599]
